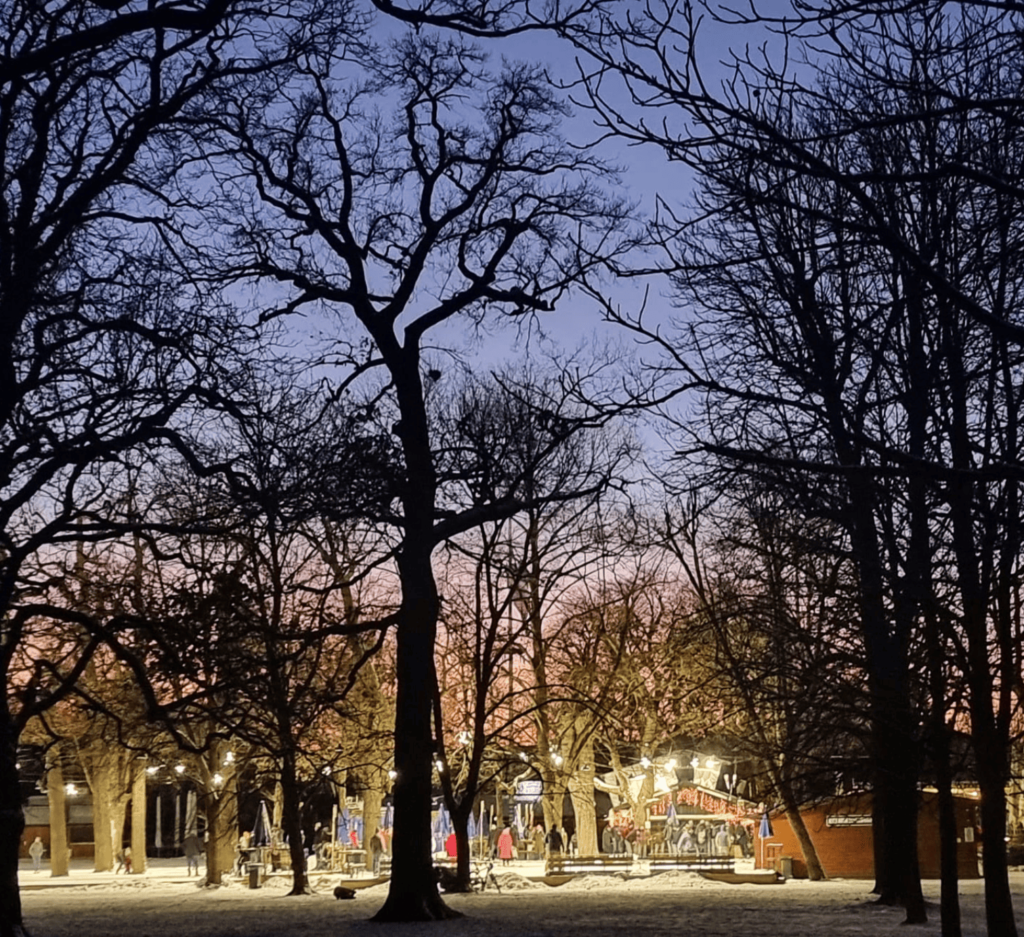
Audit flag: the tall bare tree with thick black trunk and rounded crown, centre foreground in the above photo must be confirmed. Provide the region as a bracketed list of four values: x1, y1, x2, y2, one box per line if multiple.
[185, 34, 625, 920]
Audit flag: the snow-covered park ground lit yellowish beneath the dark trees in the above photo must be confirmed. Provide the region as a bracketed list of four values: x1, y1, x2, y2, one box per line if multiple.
[20, 859, 1024, 937]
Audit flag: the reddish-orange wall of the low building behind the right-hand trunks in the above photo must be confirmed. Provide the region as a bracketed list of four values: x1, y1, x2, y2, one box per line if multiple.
[754, 794, 979, 879]
